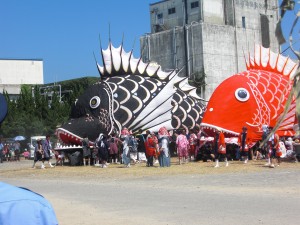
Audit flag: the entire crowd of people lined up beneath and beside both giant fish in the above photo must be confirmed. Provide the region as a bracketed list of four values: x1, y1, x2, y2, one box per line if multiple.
[0, 127, 300, 169]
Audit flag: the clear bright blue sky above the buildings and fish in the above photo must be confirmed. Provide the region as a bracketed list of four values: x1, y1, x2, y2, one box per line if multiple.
[0, 0, 299, 83]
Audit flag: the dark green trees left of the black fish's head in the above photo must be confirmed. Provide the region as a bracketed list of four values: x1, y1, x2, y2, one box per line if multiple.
[0, 77, 99, 137]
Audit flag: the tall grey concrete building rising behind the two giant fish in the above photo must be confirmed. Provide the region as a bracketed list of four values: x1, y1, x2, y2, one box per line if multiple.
[140, 0, 280, 100]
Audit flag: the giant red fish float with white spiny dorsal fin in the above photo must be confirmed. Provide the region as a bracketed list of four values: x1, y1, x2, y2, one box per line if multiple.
[201, 46, 297, 142]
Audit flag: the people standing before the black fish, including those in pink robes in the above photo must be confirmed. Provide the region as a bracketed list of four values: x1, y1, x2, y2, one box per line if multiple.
[82, 127, 207, 168]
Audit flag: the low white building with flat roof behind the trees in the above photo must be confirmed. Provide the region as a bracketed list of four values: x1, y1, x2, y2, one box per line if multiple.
[0, 59, 44, 96]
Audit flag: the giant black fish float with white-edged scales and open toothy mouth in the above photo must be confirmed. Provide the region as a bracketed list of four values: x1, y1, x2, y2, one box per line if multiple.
[57, 43, 205, 144]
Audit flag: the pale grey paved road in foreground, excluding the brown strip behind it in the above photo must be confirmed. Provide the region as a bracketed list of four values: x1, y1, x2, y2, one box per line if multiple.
[0, 159, 300, 225]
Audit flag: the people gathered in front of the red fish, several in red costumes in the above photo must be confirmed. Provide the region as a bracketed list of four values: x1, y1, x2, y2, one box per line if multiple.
[197, 127, 300, 168]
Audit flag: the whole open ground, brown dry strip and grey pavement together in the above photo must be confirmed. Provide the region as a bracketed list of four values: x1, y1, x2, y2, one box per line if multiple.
[0, 158, 300, 225]
